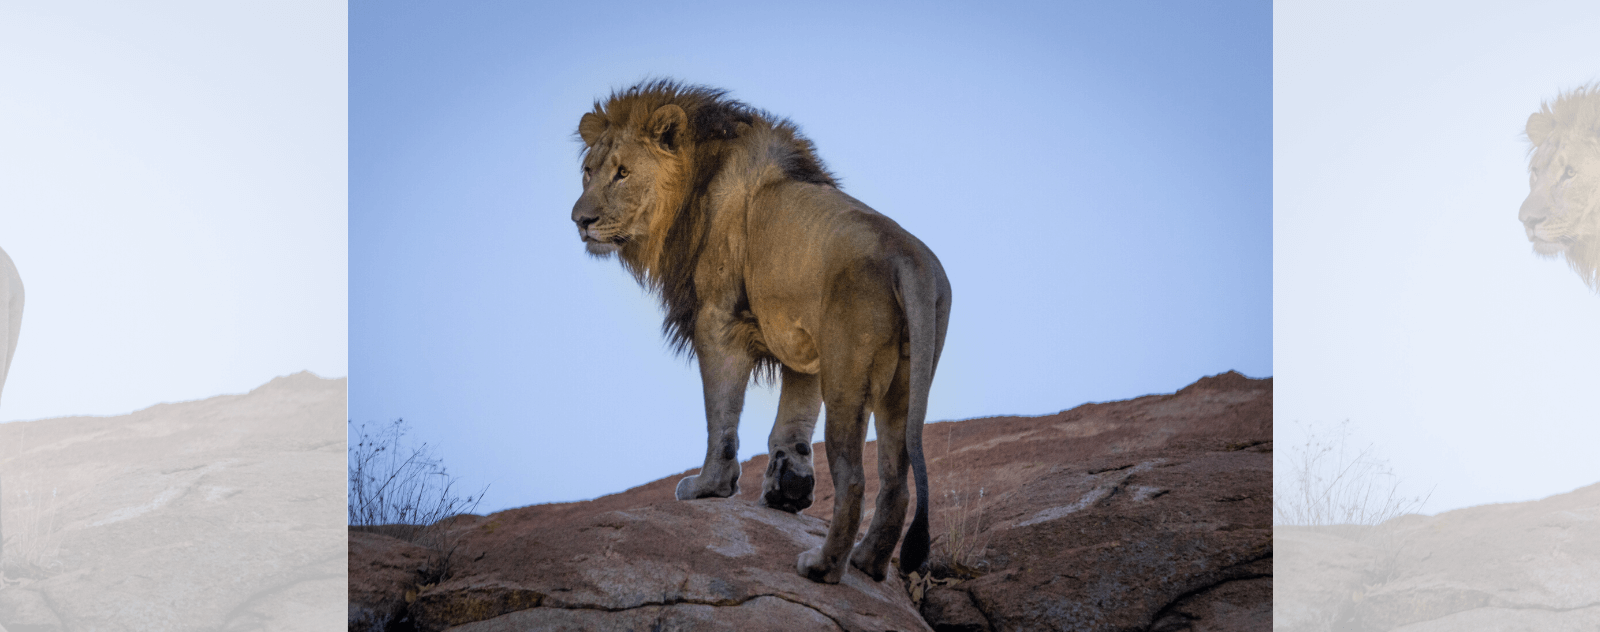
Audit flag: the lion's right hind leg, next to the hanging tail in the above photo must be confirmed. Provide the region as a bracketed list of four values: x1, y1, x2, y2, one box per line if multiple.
[850, 353, 910, 581]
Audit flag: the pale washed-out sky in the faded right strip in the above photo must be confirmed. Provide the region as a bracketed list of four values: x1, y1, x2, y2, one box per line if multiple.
[1274, 2, 1600, 514]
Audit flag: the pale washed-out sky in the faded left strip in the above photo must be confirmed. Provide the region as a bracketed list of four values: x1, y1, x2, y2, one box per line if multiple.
[0, 0, 347, 421]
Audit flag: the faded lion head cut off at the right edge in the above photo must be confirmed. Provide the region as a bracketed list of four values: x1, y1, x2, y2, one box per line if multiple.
[1517, 83, 1600, 291]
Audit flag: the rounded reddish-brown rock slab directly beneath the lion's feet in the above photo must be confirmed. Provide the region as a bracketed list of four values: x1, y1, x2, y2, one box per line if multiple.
[406, 499, 926, 630]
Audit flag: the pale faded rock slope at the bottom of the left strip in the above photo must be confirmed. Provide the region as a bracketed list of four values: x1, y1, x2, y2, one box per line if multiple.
[0, 373, 346, 630]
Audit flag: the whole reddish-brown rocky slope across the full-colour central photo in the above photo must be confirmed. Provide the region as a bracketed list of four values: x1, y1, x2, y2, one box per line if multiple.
[350, 373, 1272, 630]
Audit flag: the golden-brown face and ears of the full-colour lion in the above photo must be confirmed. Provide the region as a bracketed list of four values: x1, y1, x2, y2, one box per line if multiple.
[573, 106, 685, 256]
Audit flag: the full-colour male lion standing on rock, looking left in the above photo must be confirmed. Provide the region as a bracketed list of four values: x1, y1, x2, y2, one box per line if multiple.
[573, 80, 950, 584]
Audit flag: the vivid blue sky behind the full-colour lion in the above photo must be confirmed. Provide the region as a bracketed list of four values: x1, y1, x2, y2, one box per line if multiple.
[349, 2, 1274, 510]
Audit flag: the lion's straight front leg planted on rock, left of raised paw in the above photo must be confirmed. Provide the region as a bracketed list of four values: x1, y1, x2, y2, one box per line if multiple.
[677, 328, 755, 501]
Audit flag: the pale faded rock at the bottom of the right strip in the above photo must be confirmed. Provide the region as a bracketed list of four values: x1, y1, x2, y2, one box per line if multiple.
[1274, 485, 1600, 632]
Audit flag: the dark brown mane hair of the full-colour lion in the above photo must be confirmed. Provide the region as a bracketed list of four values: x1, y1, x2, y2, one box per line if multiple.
[582, 78, 838, 366]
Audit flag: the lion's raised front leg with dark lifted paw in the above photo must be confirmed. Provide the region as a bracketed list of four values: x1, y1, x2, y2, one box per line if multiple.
[758, 366, 822, 514]
